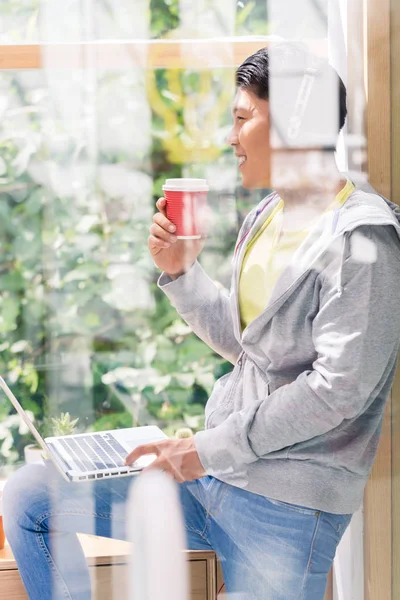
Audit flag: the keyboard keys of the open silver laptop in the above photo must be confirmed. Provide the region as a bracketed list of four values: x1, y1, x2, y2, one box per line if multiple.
[57, 433, 127, 471]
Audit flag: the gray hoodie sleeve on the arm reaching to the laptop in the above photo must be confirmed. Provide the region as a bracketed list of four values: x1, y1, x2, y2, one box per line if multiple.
[195, 226, 400, 476]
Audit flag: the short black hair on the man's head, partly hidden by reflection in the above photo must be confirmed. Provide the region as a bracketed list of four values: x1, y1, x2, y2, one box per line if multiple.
[236, 42, 347, 137]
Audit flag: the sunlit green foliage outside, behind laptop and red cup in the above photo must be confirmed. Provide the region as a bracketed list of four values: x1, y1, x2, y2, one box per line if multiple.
[0, 63, 231, 466]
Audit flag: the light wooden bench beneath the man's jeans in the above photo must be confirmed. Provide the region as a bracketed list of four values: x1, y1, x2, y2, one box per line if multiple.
[0, 535, 219, 600]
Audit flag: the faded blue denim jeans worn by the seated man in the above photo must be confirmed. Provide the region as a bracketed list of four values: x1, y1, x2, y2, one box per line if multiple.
[3, 462, 351, 600]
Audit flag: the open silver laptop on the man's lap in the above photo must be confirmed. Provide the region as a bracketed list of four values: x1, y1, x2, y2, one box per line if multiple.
[0, 377, 168, 482]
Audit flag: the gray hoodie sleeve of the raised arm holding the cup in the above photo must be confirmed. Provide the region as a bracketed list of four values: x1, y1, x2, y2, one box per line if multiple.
[158, 261, 242, 364]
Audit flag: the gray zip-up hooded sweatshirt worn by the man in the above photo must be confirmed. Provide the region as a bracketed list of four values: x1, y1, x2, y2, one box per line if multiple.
[159, 189, 400, 513]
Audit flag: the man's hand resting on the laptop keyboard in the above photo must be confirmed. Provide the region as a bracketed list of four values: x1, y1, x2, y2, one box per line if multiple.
[125, 437, 207, 483]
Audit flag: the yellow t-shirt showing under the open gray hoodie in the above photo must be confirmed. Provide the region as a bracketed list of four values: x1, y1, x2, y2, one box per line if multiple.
[239, 181, 354, 329]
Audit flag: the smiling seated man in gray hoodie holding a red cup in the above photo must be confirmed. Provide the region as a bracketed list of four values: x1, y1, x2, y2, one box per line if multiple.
[4, 45, 400, 600]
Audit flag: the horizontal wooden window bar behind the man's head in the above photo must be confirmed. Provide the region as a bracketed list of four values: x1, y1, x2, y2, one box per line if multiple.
[0, 36, 327, 70]
